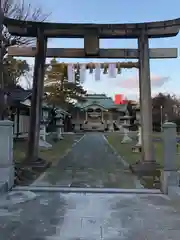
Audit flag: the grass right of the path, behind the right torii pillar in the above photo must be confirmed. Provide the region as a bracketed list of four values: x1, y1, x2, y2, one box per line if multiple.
[106, 132, 180, 168]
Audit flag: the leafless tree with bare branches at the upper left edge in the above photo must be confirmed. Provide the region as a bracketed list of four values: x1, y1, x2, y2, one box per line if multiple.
[0, 0, 50, 119]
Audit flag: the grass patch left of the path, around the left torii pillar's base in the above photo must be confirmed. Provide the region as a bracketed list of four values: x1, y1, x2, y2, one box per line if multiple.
[13, 134, 81, 185]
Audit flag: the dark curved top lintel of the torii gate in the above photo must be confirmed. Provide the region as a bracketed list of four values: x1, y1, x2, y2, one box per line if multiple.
[4, 17, 180, 38]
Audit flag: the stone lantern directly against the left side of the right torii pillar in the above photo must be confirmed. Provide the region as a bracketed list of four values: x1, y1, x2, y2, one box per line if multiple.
[132, 107, 142, 152]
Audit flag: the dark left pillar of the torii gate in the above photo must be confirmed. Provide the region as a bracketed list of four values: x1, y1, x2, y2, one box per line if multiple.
[26, 29, 47, 163]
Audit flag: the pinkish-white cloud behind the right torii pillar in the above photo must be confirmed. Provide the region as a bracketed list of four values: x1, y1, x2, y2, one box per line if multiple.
[117, 74, 169, 89]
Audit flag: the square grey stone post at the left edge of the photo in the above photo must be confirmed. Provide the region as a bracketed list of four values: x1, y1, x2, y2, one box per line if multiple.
[0, 120, 15, 189]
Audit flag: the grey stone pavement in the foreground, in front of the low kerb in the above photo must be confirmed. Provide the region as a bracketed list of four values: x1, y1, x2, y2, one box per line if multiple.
[0, 189, 180, 240]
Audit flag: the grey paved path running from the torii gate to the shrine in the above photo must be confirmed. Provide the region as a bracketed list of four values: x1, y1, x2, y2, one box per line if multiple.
[34, 133, 140, 188]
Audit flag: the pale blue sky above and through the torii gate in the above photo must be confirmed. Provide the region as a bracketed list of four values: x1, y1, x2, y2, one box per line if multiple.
[19, 0, 180, 99]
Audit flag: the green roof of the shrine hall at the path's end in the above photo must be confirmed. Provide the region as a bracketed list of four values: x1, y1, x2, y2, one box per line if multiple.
[76, 94, 127, 112]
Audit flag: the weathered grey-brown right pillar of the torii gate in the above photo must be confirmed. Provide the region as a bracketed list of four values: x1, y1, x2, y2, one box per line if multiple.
[138, 29, 155, 162]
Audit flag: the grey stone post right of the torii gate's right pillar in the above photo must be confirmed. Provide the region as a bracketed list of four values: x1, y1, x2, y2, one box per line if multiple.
[161, 122, 178, 194]
